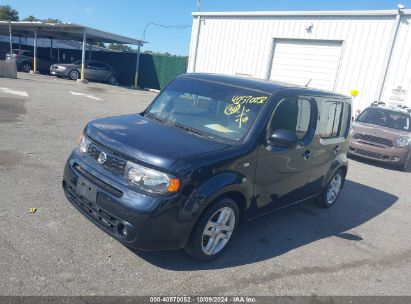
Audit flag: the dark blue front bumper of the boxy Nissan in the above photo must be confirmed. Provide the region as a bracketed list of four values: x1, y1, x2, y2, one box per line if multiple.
[62, 152, 193, 250]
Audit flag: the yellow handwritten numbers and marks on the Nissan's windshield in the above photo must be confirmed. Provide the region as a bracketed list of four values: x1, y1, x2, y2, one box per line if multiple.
[224, 96, 268, 128]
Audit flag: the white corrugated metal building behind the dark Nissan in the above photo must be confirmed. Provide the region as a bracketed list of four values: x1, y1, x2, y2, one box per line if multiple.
[188, 9, 411, 111]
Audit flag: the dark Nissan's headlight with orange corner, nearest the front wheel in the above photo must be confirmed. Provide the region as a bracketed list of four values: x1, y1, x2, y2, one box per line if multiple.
[124, 161, 180, 194]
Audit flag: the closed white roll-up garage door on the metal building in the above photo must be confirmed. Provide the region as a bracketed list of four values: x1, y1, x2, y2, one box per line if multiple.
[270, 39, 342, 91]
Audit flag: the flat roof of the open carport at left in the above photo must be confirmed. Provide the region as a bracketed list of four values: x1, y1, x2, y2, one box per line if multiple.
[0, 21, 146, 45]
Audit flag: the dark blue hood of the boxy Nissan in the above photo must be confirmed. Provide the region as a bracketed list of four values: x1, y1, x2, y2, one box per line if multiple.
[85, 114, 229, 170]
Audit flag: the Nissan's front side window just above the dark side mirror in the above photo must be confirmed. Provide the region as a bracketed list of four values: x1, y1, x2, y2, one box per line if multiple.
[270, 97, 311, 140]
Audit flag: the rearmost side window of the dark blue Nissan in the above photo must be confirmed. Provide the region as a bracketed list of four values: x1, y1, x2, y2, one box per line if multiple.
[318, 100, 343, 138]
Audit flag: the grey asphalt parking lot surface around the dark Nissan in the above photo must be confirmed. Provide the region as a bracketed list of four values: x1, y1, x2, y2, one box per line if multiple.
[0, 74, 411, 295]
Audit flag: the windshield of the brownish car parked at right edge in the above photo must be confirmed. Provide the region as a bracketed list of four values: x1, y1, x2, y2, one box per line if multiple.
[357, 108, 410, 131]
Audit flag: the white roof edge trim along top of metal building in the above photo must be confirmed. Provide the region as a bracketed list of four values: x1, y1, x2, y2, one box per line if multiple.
[192, 10, 411, 17]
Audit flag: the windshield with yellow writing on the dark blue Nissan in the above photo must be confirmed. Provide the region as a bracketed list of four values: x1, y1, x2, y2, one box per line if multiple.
[145, 78, 269, 141]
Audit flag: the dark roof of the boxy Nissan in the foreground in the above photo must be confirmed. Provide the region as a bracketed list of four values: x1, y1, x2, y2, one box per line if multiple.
[179, 73, 350, 98]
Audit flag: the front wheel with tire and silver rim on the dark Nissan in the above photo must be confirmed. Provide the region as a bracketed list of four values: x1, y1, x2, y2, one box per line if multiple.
[184, 198, 240, 262]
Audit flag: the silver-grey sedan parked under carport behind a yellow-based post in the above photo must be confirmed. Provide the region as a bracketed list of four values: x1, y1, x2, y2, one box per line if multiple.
[50, 60, 117, 85]
